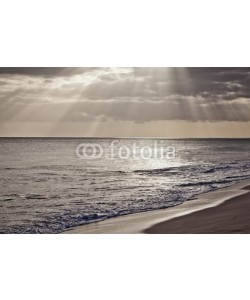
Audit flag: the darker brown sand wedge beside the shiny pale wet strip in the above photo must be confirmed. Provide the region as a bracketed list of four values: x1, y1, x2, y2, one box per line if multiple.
[144, 185, 250, 234]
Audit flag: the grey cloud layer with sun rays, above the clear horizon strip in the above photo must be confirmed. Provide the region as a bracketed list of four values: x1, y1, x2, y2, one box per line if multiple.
[0, 68, 250, 123]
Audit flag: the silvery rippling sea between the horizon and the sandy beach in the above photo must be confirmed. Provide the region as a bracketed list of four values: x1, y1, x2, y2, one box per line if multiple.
[0, 138, 250, 233]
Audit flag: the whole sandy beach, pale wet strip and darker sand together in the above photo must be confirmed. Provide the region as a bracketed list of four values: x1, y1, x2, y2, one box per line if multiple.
[63, 180, 250, 234]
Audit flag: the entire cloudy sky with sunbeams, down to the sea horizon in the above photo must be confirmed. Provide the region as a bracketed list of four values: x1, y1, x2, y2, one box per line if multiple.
[0, 67, 250, 138]
